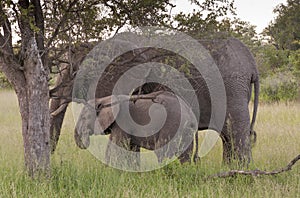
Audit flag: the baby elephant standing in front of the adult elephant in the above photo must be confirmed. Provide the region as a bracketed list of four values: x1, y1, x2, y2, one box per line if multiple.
[75, 91, 198, 167]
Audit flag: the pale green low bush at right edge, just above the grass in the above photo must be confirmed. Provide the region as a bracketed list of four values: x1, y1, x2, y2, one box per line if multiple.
[260, 72, 299, 102]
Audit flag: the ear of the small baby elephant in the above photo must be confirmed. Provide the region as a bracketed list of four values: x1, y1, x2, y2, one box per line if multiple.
[96, 96, 120, 133]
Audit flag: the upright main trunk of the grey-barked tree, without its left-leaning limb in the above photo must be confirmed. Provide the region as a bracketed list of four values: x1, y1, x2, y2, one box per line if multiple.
[18, 38, 50, 177]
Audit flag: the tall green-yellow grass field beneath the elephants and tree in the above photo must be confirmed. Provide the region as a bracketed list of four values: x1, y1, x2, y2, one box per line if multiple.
[0, 91, 300, 198]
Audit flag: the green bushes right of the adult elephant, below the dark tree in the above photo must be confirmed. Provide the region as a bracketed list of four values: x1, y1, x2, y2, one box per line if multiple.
[255, 44, 300, 102]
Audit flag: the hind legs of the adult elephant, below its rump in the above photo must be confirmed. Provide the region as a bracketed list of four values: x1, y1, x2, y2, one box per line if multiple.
[221, 105, 252, 166]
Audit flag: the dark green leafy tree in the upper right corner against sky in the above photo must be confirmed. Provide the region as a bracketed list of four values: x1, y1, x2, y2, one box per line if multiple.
[265, 0, 300, 50]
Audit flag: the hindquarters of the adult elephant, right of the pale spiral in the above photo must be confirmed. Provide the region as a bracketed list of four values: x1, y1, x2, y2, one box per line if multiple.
[200, 38, 259, 164]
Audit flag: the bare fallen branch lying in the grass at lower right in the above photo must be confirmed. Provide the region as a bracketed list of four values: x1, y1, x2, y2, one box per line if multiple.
[205, 154, 300, 180]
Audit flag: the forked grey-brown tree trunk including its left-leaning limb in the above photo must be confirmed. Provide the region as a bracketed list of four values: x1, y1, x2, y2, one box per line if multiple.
[0, 37, 50, 177]
